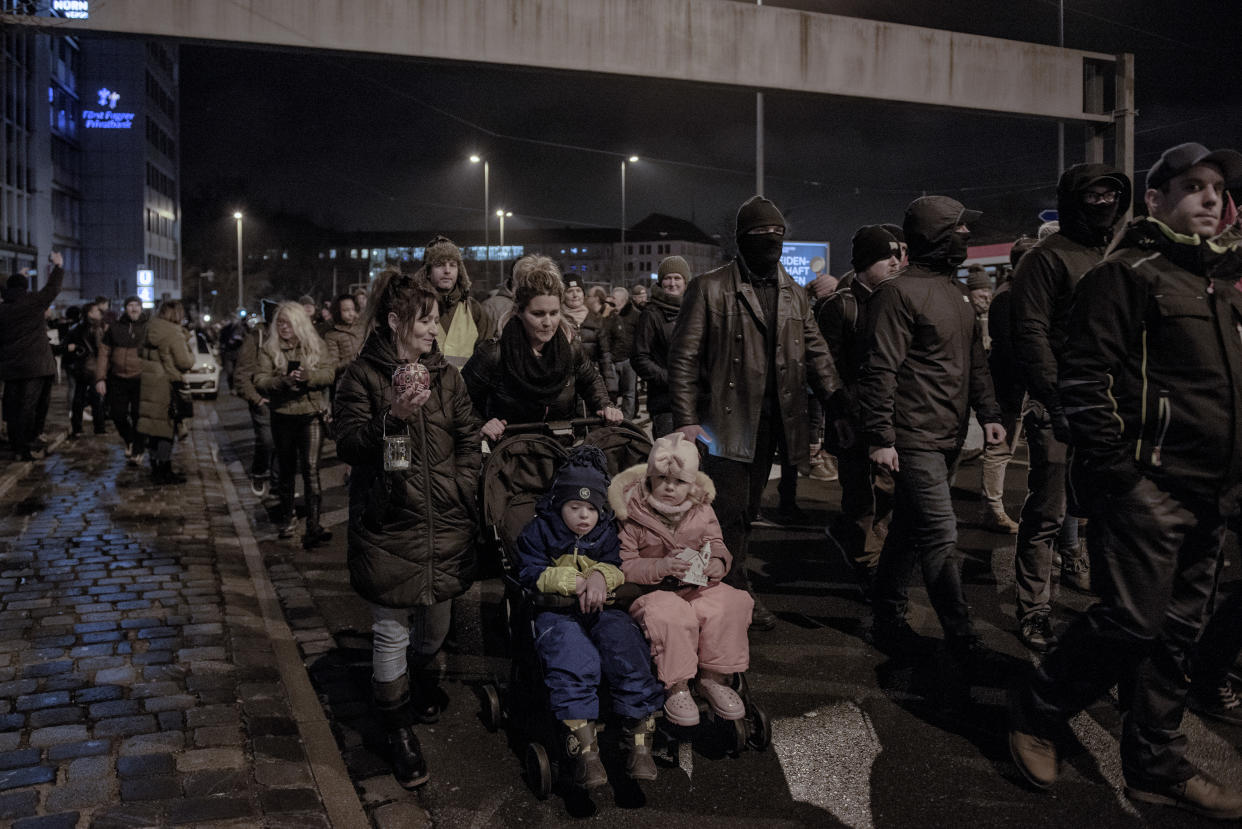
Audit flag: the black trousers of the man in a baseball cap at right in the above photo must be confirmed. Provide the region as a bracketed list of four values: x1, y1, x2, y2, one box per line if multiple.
[1020, 479, 1225, 787]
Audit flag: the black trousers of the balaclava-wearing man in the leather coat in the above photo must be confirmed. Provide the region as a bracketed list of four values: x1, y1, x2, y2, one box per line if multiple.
[703, 415, 787, 589]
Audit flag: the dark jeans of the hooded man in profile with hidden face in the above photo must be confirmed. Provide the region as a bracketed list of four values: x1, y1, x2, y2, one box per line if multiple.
[872, 449, 975, 636]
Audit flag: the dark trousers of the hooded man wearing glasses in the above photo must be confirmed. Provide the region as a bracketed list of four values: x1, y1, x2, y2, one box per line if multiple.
[1013, 408, 1068, 620]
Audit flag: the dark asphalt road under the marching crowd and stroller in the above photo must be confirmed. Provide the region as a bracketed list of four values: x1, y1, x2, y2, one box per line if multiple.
[199, 395, 1242, 829]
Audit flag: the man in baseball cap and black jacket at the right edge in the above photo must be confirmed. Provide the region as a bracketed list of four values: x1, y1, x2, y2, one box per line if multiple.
[1009, 144, 1242, 819]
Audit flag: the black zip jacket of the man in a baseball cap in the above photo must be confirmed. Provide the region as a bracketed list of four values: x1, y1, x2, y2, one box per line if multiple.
[1059, 219, 1242, 516]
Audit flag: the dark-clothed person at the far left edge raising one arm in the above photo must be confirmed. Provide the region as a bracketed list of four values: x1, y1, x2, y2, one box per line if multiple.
[0, 254, 65, 460]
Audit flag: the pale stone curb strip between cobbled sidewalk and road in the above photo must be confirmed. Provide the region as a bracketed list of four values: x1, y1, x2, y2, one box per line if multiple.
[196, 411, 371, 829]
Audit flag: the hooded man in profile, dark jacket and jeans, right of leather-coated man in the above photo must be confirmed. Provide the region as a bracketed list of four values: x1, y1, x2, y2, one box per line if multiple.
[857, 195, 1005, 665]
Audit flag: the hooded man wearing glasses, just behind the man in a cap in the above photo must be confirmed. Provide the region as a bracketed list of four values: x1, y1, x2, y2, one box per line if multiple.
[1010, 164, 1130, 653]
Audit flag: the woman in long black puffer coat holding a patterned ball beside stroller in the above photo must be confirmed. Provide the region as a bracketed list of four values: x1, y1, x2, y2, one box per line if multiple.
[333, 271, 482, 788]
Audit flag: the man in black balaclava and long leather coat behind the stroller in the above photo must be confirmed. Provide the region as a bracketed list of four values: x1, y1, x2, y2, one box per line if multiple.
[668, 195, 841, 630]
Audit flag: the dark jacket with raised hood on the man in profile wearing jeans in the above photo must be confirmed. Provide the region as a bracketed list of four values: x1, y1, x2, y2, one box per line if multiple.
[857, 205, 1001, 450]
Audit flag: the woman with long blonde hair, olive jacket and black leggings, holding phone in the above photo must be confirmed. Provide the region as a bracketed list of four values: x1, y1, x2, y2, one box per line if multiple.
[255, 302, 335, 549]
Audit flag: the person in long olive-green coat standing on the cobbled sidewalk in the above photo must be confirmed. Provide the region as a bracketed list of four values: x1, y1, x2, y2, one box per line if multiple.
[138, 300, 194, 483]
